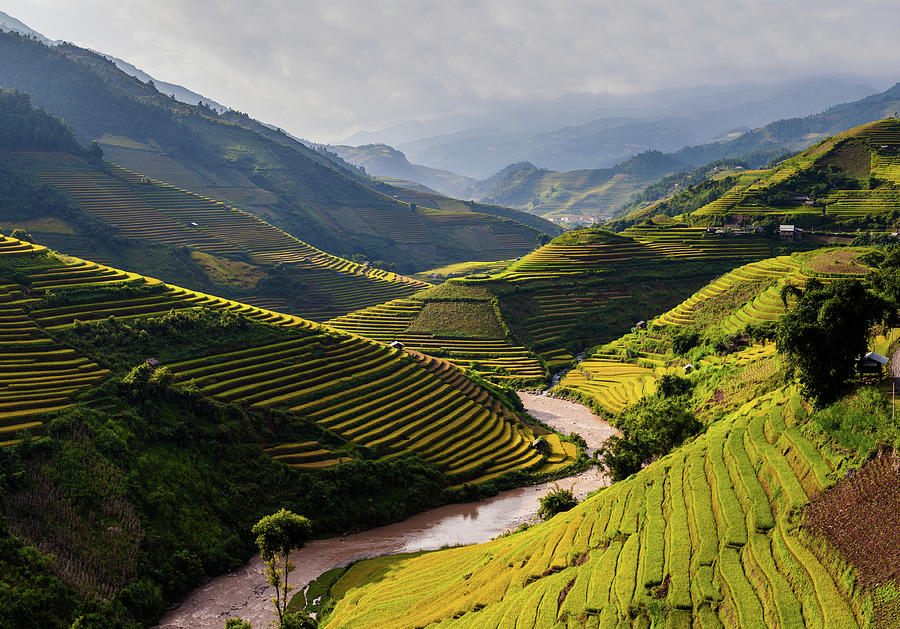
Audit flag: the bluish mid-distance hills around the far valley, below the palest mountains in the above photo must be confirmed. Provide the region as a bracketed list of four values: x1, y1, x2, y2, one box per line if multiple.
[331, 84, 900, 224]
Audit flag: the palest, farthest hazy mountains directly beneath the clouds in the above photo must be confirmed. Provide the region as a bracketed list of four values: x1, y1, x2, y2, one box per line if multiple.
[390, 76, 875, 178]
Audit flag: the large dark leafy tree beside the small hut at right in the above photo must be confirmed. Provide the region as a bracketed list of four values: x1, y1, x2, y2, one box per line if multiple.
[775, 279, 892, 408]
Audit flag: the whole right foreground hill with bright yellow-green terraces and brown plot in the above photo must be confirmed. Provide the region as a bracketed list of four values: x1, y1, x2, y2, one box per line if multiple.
[319, 243, 900, 628]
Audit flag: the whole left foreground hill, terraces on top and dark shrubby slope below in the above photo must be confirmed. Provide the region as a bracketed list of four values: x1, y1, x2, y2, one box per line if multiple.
[0, 237, 577, 628]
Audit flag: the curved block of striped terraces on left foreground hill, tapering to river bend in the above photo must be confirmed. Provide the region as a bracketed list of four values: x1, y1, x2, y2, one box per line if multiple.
[170, 334, 544, 482]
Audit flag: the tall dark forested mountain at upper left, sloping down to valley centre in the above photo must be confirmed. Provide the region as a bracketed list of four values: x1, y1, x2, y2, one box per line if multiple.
[0, 28, 553, 271]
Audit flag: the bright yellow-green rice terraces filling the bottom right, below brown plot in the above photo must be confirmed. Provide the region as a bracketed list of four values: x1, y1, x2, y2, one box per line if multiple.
[325, 391, 863, 629]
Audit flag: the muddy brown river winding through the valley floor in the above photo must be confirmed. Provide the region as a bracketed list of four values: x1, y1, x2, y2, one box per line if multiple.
[158, 393, 615, 629]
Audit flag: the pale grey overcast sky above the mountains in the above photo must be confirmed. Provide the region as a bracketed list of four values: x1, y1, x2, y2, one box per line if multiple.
[7, 0, 900, 141]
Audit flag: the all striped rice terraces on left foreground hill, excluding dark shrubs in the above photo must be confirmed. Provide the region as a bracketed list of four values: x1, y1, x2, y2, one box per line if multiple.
[0, 245, 572, 483]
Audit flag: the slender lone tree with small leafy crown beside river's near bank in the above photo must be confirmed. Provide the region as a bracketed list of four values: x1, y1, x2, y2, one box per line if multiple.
[252, 509, 312, 627]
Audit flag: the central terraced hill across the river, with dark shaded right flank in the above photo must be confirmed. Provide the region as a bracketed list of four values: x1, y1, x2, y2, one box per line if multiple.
[329, 228, 772, 378]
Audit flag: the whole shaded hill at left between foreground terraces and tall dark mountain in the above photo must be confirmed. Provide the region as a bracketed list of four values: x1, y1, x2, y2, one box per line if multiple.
[0, 134, 426, 320]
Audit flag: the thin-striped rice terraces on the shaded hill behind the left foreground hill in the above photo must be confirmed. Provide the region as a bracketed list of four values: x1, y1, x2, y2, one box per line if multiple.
[23, 153, 428, 320]
